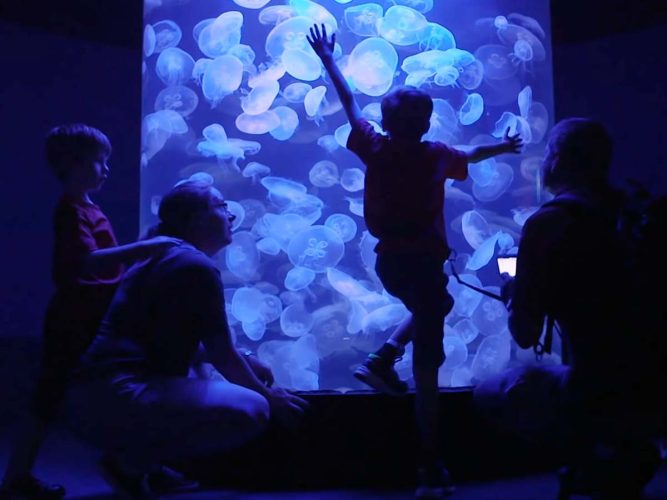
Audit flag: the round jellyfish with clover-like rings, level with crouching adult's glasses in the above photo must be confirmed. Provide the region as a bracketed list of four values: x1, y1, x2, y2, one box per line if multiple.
[287, 226, 345, 273]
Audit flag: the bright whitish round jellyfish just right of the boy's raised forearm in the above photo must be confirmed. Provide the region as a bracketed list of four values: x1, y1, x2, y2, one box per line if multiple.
[349, 37, 398, 97]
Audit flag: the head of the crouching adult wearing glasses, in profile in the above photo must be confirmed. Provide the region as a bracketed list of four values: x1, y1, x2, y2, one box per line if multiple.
[156, 181, 236, 255]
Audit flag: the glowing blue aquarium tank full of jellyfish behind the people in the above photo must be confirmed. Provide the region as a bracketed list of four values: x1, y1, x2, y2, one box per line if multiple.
[140, 0, 560, 392]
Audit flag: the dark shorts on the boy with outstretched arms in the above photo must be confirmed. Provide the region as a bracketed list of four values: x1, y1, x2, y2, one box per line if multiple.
[375, 253, 454, 368]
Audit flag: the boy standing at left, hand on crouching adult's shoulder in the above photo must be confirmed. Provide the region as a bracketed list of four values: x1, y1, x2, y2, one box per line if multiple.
[0, 124, 180, 498]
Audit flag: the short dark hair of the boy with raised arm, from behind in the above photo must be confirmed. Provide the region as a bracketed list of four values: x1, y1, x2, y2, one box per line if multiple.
[380, 87, 433, 138]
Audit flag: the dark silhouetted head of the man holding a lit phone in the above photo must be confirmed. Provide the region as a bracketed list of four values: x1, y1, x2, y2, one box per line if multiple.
[542, 118, 612, 191]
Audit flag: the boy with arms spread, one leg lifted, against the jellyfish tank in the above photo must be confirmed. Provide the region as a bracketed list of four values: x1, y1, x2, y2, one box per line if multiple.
[308, 25, 522, 498]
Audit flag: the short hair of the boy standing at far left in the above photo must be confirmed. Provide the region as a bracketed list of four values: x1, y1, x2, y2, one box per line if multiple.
[44, 123, 111, 180]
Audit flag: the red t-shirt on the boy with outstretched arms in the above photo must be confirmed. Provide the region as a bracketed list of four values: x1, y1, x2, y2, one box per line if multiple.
[347, 120, 468, 255]
